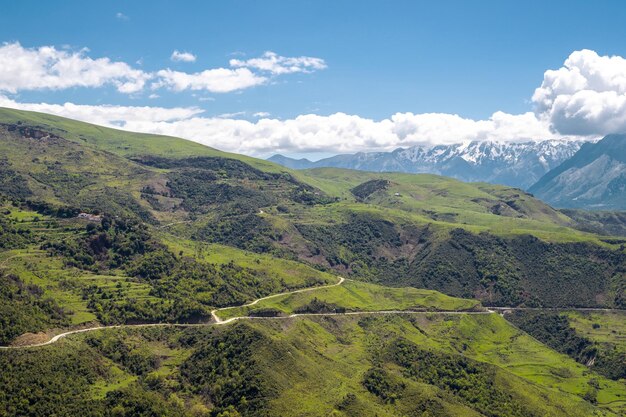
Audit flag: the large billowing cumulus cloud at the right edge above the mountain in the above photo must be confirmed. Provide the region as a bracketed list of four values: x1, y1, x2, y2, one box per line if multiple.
[532, 49, 626, 136]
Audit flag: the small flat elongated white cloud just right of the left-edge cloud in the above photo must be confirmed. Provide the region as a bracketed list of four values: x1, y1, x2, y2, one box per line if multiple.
[153, 68, 268, 93]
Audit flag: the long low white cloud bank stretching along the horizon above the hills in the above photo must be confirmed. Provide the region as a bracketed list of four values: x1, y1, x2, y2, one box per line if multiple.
[0, 98, 554, 155]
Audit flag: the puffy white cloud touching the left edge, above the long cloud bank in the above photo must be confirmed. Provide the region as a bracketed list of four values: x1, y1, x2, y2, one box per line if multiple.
[0, 42, 150, 93]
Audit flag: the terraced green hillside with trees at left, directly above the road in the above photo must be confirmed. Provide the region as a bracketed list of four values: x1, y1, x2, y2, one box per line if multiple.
[0, 202, 336, 338]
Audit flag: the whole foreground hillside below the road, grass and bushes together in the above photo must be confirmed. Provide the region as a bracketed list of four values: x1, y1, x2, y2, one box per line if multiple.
[0, 313, 626, 417]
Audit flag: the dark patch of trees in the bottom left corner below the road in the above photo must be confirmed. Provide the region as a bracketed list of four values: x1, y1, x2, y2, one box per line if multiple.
[0, 342, 188, 417]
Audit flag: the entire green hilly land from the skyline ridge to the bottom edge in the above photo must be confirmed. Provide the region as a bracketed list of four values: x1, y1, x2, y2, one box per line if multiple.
[0, 109, 626, 417]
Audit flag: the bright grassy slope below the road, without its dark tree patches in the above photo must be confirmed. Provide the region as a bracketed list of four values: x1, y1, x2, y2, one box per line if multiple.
[0, 313, 626, 417]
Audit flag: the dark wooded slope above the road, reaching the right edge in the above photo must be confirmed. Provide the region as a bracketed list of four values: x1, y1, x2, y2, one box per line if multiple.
[296, 214, 626, 307]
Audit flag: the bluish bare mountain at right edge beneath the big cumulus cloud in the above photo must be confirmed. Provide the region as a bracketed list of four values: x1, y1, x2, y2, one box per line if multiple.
[530, 134, 626, 210]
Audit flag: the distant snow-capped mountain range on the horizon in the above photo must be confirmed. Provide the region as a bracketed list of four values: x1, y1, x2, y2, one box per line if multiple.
[269, 140, 584, 189]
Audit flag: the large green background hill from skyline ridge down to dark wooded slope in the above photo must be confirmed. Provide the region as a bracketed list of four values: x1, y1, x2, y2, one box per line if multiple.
[0, 106, 626, 308]
